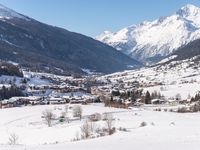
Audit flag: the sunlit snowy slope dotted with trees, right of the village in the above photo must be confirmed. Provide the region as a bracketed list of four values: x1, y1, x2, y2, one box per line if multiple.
[97, 55, 200, 100]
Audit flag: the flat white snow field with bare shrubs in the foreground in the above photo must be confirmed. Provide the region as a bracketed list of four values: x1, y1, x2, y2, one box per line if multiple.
[0, 104, 200, 150]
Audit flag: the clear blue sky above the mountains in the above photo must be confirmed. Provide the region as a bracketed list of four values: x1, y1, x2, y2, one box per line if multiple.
[0, 0, 200, 37]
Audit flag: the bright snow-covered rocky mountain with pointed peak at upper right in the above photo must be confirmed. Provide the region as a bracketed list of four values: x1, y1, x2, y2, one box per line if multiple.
[96, 4, 200, 61]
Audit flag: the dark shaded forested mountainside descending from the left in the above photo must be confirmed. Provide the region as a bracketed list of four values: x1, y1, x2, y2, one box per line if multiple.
[0, 6, 141, 74]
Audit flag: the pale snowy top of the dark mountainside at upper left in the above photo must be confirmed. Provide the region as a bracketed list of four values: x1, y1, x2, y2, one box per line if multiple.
[0, 4, 29, 20]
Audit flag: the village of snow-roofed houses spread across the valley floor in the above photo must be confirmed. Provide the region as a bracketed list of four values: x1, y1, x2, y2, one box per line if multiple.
[0, 70, 194, 109]
